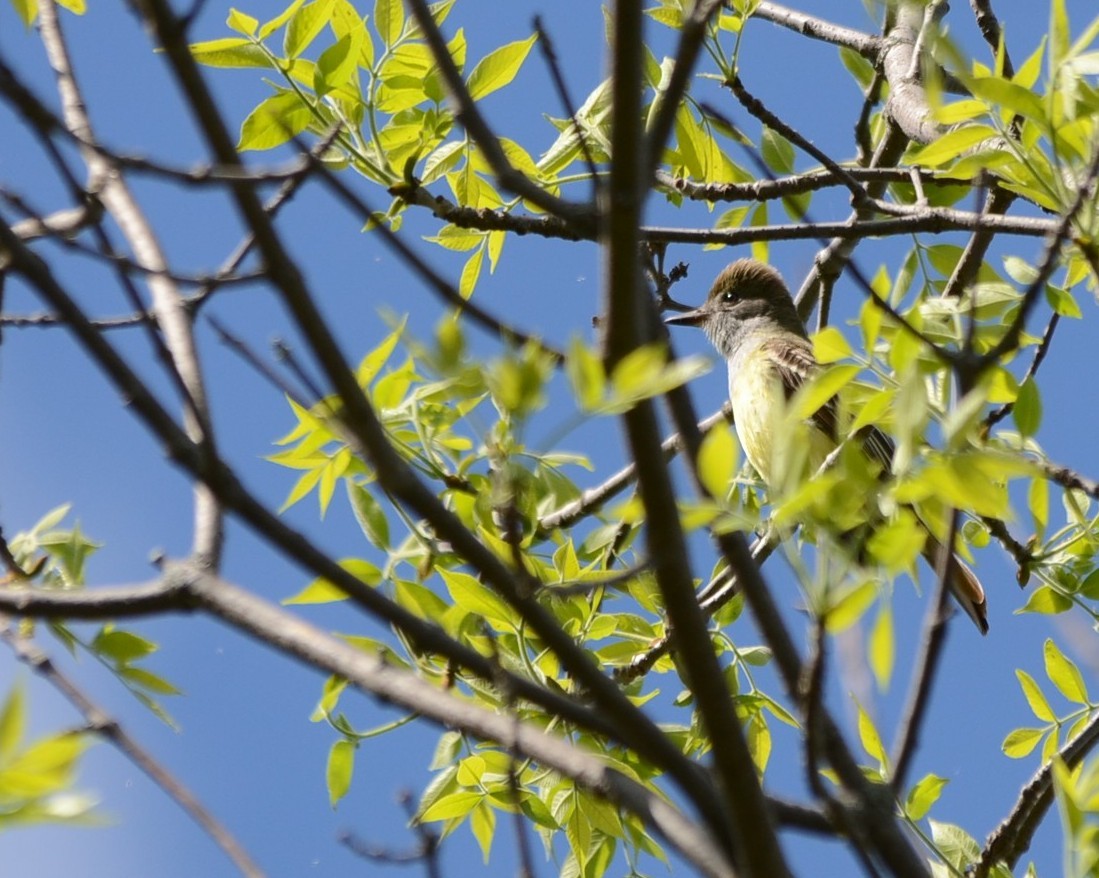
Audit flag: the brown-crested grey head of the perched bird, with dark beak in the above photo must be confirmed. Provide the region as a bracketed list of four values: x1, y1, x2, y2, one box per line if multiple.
[664, 259, 804, 359]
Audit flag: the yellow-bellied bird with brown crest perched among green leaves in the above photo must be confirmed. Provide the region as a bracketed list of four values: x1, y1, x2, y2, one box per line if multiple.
[665, 259, 988, 634]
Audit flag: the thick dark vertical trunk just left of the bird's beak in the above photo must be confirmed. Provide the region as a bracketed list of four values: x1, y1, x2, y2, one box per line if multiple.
[601, 0, 789, 878]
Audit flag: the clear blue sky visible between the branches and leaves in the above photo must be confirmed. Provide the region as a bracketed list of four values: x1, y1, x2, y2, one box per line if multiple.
[0, 0, 1099, 878]
